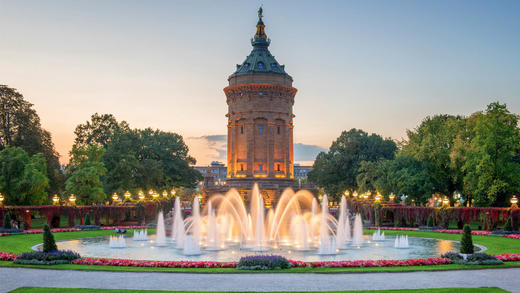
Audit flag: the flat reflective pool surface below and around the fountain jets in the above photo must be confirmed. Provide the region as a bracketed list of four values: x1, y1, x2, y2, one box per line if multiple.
[53, 235, 478, 261]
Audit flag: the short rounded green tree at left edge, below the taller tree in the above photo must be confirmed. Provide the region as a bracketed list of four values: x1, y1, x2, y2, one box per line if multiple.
[0, 146, 49, 205]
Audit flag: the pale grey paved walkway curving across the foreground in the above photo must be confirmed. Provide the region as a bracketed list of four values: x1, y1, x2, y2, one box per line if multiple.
[0, 268, 520, 292]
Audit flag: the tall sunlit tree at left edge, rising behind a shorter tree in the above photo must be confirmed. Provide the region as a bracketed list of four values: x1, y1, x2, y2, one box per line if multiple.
[0, 85, 65, 193]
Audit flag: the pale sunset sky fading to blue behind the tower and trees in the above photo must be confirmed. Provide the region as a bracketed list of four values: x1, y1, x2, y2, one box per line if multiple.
[0, 0, 520, 165]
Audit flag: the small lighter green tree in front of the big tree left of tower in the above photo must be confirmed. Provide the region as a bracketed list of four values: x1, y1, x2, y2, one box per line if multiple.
[65, 145, 106, 204]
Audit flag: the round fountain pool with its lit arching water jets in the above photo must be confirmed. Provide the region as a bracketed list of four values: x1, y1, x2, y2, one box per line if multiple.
[54, 186, 474, 261]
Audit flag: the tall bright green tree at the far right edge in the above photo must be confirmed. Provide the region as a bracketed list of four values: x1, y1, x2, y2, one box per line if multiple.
[462, 102, 520, 206]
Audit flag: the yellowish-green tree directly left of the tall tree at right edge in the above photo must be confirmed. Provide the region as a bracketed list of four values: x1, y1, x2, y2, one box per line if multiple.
[402, 114, 465, 196]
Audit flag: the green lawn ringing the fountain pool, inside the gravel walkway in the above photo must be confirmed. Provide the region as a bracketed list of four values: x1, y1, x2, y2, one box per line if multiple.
[0, 229, 520, 273]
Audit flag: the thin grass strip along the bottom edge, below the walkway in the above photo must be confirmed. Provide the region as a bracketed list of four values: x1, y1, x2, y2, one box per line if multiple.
[6, 287, 508, 293]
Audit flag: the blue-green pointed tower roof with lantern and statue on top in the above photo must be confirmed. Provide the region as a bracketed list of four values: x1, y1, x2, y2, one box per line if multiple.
[230, 8, 292, 79]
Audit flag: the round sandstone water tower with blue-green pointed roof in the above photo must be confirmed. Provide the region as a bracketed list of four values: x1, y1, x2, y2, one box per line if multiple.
[224, 9, 297, 203]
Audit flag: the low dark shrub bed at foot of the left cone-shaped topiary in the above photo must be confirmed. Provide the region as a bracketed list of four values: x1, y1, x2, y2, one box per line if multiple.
[14, 250, 81, 265]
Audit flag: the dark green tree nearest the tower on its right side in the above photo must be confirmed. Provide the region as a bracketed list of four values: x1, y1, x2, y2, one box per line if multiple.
[309, 129, 397, 199]
